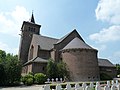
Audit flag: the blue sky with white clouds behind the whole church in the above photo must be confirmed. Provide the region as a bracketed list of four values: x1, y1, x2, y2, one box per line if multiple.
[0, 0, 120, 63]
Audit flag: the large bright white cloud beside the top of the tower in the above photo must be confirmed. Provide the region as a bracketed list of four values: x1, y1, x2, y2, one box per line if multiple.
[0, 6, 30, 36]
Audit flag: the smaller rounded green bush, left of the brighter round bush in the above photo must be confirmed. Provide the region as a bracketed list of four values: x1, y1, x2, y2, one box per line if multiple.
[21, 74, 34, 85]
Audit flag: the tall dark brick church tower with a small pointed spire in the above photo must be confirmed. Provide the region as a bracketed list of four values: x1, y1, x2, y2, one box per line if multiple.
[18, 13, 41, 64]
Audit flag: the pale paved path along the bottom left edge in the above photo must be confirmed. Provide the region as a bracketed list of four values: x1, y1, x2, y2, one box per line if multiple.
[0, 85, 43, 90]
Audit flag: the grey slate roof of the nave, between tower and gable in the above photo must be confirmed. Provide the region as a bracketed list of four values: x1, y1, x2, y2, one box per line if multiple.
[32, 34, 58, 50]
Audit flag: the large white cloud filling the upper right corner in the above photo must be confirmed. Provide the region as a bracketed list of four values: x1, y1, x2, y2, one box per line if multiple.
[95, 0, 120, 24]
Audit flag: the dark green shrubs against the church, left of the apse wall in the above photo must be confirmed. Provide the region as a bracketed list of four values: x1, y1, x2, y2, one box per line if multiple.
[47, 59, 69, 79]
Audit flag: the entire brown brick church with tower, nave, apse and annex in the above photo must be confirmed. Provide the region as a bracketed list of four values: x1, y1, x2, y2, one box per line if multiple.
[18, 13, 116, 81]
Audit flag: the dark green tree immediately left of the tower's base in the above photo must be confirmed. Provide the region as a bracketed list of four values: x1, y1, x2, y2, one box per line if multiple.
[6, 56, 22, 85]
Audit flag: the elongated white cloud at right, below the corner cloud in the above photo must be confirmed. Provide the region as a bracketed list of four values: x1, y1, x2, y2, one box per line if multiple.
[89, 25, 120, 43]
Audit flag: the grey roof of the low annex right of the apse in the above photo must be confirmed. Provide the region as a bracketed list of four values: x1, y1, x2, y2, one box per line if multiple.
[98, 58, 115, 67]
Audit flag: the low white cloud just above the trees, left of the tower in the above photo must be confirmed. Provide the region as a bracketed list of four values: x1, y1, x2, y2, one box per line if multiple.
[0, 42, 18, 55]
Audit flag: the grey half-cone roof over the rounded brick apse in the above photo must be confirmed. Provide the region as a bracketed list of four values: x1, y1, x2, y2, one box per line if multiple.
[63, 37, 93, 50]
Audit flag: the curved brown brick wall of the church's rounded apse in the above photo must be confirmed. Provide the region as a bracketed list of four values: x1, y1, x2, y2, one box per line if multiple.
[62, 49, 99, 81]
